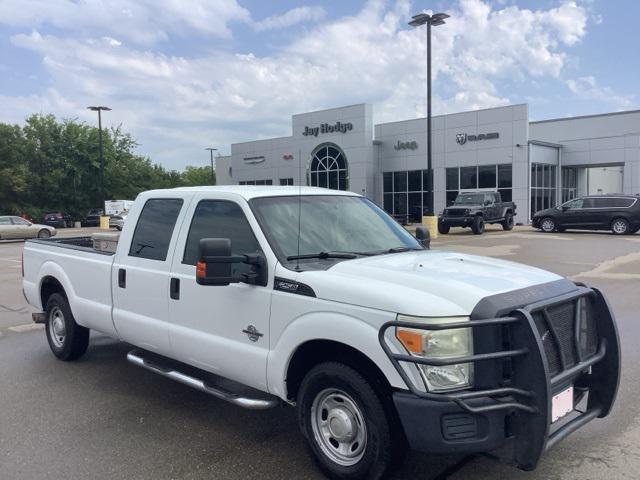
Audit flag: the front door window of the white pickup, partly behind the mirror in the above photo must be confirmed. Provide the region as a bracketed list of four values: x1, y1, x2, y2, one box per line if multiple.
[182, 200, 260, 273]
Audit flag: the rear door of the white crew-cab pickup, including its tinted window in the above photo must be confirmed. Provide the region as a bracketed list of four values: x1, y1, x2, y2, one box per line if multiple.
[111, 192, 190, 355]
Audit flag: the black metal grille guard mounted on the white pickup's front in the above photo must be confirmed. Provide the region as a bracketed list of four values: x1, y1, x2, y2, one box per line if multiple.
[378, 285, 620, 470]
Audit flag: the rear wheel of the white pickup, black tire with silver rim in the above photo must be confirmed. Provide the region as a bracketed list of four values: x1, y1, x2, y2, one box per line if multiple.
[45, 293, 89, 362]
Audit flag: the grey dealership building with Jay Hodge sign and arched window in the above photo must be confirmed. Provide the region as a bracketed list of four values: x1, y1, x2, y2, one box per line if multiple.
[216, 104, 640, 223]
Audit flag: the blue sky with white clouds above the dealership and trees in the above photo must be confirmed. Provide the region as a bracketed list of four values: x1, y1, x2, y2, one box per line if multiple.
[0, 0, 640, 170]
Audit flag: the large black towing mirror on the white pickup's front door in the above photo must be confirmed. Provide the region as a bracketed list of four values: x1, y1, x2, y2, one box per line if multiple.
[196, 238, 267, 286]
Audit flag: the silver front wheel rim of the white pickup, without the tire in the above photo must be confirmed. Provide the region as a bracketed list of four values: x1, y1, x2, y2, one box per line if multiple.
[311, 388, 367, 467]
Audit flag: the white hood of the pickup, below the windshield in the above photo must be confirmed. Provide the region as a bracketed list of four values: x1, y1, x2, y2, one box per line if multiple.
[298, 250, 562, 317]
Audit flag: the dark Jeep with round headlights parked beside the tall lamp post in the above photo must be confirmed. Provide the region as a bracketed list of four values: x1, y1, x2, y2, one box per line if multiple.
[438, 192, 516, 235]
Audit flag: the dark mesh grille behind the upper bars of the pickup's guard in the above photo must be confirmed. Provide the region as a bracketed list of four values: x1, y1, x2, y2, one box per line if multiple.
[533, 297, 598, 375]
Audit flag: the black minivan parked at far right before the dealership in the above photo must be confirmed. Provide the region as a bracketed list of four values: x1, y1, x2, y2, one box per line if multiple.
[531, 195, 640, 235]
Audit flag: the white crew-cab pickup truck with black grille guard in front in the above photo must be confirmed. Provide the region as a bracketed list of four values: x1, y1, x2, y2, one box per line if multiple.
[23, 186, 620, 479]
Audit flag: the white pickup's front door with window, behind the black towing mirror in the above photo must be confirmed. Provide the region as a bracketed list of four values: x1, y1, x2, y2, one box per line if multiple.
[169, 193, 273, 390]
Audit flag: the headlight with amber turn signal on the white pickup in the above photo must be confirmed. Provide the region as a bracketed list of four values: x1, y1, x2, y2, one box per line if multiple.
[396, 315, 473, 392]
